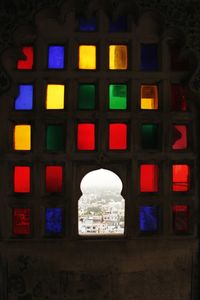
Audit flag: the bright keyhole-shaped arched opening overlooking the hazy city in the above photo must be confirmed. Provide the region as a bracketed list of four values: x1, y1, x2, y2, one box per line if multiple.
[78, 169, 125, 235]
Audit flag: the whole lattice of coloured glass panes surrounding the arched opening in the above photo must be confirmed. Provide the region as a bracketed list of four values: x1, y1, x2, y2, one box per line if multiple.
[10, 11, 194, 237]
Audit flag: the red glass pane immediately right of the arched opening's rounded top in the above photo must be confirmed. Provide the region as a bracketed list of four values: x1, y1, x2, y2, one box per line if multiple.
[140, 164, 158, 192]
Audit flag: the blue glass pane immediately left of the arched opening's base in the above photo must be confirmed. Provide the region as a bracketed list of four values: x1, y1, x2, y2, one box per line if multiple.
[45, 208, 62, 234]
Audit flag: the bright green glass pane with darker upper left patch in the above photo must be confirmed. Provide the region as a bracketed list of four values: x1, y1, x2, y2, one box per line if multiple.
[109, 84, 127, 109]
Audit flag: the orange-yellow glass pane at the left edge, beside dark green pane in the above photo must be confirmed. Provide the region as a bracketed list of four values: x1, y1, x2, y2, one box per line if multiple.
[14, 125, 31, 150]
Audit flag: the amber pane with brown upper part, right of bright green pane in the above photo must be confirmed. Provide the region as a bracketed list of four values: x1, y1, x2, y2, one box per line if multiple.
[140, 85, 158, 109]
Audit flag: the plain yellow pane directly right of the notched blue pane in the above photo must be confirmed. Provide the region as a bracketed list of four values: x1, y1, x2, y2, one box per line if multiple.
[46, 84, 65, 109]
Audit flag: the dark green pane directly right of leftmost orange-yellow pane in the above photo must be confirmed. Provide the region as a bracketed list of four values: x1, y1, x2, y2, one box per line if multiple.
[46, 125, 64, 151]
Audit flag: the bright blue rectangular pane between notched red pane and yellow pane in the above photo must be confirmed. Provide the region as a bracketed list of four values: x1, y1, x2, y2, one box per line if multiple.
[48, 46, 65, 69]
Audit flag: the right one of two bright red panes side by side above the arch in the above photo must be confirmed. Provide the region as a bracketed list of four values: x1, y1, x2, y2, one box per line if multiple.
[109, 124, 127, 150]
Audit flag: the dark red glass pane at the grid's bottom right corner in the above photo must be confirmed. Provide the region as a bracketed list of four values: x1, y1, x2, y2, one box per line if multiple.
[173, 205, 189, 233]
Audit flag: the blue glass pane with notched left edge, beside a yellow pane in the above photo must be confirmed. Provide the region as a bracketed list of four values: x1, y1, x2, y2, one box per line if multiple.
[15, 84, 33, 110]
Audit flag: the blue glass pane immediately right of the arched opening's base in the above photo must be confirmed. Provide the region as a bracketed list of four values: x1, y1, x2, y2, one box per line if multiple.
[140, 206, 158, 232]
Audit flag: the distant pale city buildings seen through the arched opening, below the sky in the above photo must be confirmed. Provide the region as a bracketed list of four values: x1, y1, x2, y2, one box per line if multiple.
[78, 188, 125, 235]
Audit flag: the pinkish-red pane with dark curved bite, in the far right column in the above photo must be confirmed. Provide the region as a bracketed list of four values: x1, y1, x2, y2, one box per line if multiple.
[172, 125, 187, 150]
